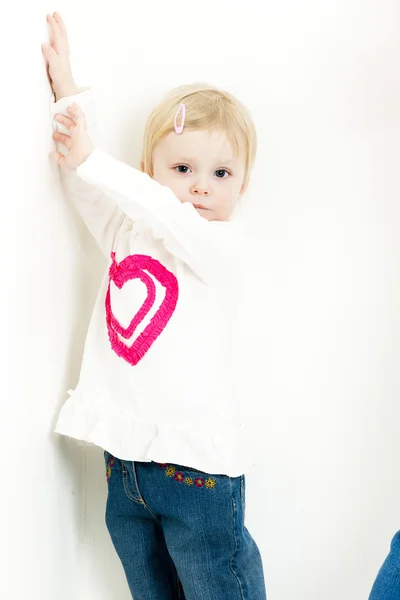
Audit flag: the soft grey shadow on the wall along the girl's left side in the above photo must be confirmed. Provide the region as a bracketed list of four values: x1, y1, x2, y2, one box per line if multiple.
[50, 167, 130, 600]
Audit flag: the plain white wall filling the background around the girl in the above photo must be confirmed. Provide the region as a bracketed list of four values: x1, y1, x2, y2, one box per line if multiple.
[0, 0, 400, 600]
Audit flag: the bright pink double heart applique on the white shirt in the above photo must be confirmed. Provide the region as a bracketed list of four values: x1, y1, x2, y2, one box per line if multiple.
[106, 252, 179, 366]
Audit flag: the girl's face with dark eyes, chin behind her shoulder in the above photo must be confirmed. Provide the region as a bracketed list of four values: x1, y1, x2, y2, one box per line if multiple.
[149, 129, 245, 221]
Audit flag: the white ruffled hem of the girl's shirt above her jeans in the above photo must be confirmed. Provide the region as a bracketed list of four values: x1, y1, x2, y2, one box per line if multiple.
[55, 391, 254, 477]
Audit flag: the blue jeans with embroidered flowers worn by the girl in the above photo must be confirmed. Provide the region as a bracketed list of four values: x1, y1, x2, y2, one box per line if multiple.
[104, 452, 266, 600]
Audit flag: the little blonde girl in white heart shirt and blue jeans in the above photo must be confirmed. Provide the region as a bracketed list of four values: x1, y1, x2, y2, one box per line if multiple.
[43, 13, 266, 600]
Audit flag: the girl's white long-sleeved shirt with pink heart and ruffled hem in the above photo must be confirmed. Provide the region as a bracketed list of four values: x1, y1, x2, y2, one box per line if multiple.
[51, 89, 252, 477]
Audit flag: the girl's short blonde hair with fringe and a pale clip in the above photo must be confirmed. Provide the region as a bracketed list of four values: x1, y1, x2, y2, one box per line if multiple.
[141, 83, 257, 188]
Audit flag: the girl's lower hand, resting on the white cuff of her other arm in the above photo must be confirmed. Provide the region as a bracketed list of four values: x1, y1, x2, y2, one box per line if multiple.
[50, 103, 94, 170]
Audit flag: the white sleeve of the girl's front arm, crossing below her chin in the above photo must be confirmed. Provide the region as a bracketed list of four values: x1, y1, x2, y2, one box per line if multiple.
[77, 149, 239, 282]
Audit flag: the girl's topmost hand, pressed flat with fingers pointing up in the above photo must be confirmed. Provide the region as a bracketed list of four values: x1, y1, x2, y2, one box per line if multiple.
[42, 12, 79, 101]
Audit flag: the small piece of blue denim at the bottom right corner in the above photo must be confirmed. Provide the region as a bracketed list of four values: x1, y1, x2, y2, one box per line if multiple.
[369, 531, 400, 600]
